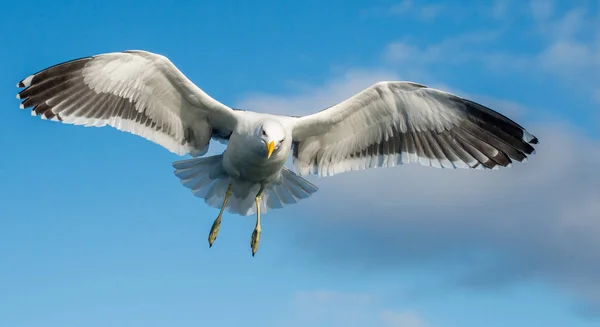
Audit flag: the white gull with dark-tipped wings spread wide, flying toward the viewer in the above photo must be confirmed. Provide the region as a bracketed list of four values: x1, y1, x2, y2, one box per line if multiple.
[17, 50, 538, 256]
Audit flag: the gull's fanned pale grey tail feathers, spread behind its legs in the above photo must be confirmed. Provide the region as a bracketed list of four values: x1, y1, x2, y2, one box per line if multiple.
[173, 155, 318, 216]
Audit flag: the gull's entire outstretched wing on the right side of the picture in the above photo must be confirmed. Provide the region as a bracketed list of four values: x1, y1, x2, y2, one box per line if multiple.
[292, 82, 537, 176]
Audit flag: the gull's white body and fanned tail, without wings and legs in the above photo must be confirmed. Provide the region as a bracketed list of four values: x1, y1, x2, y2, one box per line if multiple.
[173, 112, 318, 216]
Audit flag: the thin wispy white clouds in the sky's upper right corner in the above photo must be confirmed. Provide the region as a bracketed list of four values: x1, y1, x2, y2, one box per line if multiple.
[383, 0, 600, 113]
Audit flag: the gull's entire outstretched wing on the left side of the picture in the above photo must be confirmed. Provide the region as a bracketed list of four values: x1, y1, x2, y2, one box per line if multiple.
[17, 50, 237, 156]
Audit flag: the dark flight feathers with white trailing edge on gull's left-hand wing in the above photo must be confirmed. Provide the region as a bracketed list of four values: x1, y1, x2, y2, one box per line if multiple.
[16, 51, 239, 156]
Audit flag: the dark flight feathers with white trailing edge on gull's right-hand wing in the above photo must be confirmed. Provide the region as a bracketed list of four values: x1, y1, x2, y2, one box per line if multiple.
[292, 83, 539, 176]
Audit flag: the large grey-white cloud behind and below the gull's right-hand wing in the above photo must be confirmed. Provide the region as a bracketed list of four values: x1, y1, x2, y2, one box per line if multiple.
[237, 64, 600, 312]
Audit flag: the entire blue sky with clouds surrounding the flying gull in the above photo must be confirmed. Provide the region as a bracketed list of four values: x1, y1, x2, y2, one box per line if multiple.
[0, 0, 600, 327]
